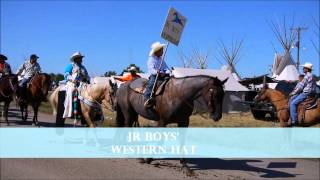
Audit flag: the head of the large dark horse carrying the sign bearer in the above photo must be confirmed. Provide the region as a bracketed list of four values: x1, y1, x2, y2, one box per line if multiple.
[202, 78, 228, 121]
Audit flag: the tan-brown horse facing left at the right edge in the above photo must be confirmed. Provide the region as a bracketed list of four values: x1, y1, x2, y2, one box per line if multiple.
[256, 85, 320, 127]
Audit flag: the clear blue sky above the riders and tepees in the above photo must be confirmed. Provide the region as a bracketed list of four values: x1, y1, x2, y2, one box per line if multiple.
[0, 0, 320, 77]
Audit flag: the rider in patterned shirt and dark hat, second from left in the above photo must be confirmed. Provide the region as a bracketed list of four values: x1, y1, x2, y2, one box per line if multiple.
[16, 54, 41, 100]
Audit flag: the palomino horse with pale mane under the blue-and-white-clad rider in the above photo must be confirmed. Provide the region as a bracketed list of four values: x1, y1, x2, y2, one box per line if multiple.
[49, 79, 115, 127]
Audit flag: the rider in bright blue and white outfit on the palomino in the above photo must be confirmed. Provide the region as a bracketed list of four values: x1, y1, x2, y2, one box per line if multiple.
[63, 52, 90, 118]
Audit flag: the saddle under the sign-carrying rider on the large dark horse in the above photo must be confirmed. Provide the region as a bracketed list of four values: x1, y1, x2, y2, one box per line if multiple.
[129, 78, 170, 96]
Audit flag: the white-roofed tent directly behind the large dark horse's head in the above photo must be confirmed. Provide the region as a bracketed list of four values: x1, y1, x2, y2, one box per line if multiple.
[172, 67, 249, 113]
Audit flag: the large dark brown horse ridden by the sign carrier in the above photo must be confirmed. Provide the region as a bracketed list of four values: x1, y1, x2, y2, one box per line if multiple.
[116, 76, 227, 175]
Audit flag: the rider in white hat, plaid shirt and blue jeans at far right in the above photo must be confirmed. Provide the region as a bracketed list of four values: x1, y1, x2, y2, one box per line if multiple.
[289, 63, 316, 126]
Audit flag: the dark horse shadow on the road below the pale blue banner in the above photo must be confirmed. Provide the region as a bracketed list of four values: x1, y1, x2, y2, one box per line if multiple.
[188, 158, 298, 178]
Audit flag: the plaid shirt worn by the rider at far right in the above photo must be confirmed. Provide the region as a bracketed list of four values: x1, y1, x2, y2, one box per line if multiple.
[291, 72, 316, 95]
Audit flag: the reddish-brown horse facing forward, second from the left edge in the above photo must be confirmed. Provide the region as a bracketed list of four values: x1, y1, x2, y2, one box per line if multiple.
[19, 73, 52, 125]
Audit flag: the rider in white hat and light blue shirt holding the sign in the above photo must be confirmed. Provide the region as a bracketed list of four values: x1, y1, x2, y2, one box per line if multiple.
[144, 42, 170, 108]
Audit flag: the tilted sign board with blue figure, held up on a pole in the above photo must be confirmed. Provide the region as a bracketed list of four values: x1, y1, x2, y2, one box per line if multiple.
[161, 8, 187, 46]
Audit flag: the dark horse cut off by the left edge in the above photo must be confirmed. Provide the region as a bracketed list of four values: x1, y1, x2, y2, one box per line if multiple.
[0, 75, 18, 125]
